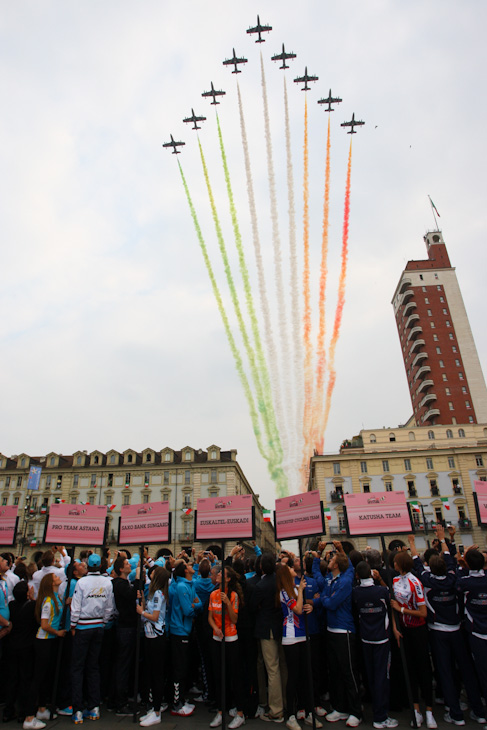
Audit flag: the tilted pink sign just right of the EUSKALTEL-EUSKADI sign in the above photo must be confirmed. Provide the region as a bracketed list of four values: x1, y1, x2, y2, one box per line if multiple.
[276, 489, 324, 540]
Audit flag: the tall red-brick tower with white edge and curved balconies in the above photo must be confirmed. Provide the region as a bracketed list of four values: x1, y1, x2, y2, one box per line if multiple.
[392, 231, 487, 426]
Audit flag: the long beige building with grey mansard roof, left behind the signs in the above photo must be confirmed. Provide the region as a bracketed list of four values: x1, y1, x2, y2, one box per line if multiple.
[0, 445, 275, 555]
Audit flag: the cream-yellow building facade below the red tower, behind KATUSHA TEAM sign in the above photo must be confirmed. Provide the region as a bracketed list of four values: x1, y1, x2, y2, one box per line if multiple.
[309, 424, 487, 549]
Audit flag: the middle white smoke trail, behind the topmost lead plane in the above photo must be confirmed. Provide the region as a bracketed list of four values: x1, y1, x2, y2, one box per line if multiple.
[260, 53, 291, 484]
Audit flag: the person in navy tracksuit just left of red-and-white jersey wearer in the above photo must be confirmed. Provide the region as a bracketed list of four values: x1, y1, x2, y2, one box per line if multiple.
[352, 561, 398, 728]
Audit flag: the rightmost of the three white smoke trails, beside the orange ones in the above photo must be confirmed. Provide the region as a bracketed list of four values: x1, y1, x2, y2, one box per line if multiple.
[284, 76, 304, 484]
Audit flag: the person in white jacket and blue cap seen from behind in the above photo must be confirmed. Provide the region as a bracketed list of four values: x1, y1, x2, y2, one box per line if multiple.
[71, 554, 115, 725]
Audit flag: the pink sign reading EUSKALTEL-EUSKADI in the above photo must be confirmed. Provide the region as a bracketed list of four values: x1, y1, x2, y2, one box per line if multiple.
[195, 494, 254, 540]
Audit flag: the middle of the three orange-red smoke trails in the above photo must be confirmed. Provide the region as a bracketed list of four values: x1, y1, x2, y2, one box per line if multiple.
[312, 115, 330, 454]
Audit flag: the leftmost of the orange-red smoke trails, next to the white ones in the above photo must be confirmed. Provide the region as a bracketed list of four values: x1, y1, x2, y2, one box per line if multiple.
[301, 98, 313, 489]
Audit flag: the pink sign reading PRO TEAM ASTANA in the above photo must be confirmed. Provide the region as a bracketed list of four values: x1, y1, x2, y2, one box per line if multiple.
[45, 504, 107, 547]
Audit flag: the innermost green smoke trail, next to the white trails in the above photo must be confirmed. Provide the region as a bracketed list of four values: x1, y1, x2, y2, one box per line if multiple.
[216, 114, 282, 461]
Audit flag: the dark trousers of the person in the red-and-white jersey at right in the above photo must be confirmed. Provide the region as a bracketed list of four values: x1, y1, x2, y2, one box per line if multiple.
[400, 625, 433, 707]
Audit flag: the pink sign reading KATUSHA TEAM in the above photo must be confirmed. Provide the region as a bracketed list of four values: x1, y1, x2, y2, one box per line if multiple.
[344, 492, 412, 535]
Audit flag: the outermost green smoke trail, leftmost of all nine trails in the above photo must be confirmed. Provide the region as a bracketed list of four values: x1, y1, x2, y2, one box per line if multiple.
[178, 161, 268, 460]
